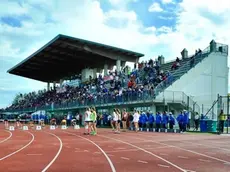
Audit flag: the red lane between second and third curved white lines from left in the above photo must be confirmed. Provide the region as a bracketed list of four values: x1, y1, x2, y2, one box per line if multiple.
[0, 131, 60, 172]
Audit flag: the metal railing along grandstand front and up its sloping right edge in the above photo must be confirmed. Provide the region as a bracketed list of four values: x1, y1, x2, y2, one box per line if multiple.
[4, 43, 228, 113]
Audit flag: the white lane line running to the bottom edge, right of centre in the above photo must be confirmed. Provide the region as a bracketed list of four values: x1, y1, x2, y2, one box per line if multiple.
[98, 135, 186, 172]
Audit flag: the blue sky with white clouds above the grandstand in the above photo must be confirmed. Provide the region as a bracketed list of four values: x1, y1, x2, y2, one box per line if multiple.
[0, 0, 230, 108]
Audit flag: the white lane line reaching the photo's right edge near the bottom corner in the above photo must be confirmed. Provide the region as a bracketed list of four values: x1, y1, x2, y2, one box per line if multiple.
[126, 136, 230, 163]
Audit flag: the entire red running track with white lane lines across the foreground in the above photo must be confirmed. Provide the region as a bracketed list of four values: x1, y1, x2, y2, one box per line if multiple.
[0, 128, 230, 172]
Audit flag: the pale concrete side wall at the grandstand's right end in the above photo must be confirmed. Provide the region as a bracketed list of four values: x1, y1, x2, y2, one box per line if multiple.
[166, 52, 228, 118]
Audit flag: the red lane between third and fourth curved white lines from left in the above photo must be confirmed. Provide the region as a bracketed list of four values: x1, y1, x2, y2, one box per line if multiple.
[47, 129, 115, 172]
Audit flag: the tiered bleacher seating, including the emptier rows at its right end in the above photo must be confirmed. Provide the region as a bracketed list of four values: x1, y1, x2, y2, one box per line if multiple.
[3, 47, 211, 110]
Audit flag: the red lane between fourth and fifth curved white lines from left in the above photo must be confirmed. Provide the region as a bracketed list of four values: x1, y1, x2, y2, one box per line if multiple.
[66, 130, 182, 172]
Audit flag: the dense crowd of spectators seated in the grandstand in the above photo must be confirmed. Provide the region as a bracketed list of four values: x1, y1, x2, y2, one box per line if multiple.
[6, 55, 190, 110]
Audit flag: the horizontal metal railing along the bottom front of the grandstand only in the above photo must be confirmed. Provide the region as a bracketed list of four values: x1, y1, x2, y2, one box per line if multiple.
[4, 90, 196, 112]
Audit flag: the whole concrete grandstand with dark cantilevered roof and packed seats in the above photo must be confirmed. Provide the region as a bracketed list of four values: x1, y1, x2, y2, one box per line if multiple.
[1, 35, 229, 133]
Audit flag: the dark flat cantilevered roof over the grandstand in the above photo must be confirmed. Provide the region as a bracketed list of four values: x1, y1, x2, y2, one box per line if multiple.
[7, 34, 144, 82]
